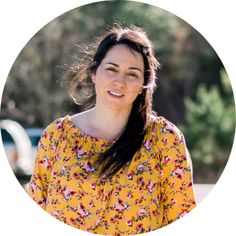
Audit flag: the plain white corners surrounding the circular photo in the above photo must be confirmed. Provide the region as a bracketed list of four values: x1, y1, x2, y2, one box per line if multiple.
[0, 0, 236, 236]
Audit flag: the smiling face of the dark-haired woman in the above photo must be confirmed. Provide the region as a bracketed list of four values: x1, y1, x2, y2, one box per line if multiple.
[92, 44, 144, 112]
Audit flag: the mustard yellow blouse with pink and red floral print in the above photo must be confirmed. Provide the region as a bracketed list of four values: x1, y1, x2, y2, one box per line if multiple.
[28, 115, 195, 235]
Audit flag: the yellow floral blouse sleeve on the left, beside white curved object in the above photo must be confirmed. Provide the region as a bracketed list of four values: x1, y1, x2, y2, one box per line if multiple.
[28, 119, 62, 209]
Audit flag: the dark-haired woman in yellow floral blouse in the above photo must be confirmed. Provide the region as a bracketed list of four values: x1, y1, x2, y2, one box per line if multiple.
[29, 26, 195, 235]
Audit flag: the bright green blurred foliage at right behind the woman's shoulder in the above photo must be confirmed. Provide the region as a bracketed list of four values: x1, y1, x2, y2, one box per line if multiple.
[182, 72, 235, 182]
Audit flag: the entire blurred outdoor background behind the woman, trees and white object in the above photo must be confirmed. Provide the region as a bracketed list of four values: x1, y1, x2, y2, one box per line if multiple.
[0, 1, 235, 202]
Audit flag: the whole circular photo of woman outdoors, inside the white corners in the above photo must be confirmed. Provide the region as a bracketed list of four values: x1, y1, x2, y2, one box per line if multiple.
[0, 1, 235, 236]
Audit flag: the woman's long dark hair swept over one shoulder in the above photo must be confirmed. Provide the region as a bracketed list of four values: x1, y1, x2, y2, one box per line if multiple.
[70, 25, 159, 177]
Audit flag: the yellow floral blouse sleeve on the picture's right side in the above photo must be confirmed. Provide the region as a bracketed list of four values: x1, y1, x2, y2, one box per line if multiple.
[158, 118, 196, 226]
